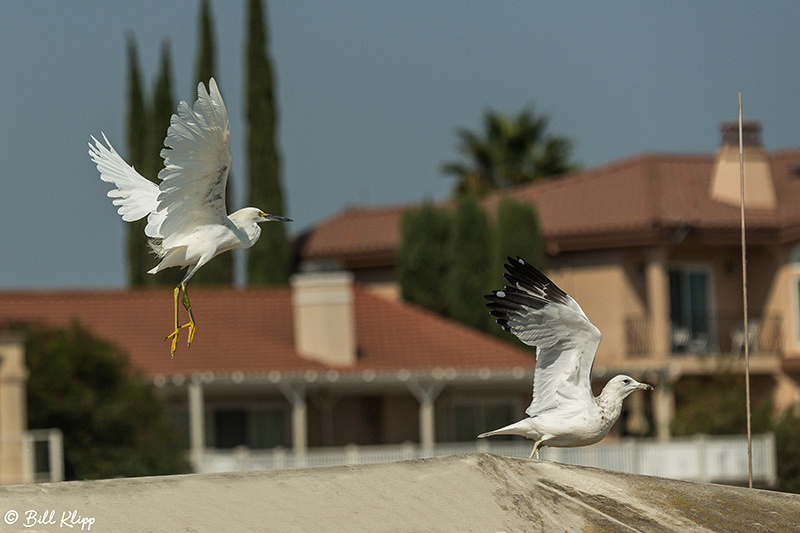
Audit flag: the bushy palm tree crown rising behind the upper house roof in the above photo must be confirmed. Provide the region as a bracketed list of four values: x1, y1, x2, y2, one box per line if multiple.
[442, 107, 577, 196]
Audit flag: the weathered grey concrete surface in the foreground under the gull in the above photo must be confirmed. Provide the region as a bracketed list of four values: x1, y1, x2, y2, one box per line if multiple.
[0, 454, 800, 533]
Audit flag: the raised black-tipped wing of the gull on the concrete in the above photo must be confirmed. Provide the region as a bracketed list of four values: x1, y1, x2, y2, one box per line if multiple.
[486, 257, 601, 416]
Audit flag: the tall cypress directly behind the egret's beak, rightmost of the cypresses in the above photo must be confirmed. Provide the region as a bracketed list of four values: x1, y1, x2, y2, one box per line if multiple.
[245, 0, 290, 284]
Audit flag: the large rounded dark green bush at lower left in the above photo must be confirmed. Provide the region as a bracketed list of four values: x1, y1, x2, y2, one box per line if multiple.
[25, 323, 190, 479]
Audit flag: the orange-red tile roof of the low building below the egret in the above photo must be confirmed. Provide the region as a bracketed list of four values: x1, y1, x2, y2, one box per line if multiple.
[0, 287, 534, 377]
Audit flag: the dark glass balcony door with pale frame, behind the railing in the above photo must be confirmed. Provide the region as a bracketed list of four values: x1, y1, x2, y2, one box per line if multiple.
[669, 266, 715, 354]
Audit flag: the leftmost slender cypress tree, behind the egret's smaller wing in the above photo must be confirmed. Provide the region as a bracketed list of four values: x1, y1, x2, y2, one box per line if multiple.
[125, 34, 152, 286]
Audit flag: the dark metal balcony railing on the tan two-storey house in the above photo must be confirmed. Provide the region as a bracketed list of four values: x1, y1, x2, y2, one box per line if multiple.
[625, 314, 783, 357]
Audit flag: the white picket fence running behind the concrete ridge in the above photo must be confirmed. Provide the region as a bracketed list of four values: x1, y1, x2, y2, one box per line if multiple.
[200, 433, 777, 486]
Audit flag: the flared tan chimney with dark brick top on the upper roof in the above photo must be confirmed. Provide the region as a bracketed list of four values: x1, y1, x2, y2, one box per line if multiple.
[711, 120, 775, 209]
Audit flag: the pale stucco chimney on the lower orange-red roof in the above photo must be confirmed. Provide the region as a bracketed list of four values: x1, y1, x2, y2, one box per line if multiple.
[291, 271, 356, 366]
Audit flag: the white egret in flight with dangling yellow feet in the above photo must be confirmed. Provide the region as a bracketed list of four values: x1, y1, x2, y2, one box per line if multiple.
[89, 78, 291, 357]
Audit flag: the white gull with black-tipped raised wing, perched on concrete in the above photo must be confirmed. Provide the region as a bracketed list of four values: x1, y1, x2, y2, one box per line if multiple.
[478, 257, 653, 459]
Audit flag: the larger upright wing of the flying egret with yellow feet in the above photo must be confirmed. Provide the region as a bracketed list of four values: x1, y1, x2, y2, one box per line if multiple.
[145, 78, 231, 248]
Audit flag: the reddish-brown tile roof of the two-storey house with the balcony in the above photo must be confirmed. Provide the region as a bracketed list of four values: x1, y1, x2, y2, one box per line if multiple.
[301, 149, 800, 265]
